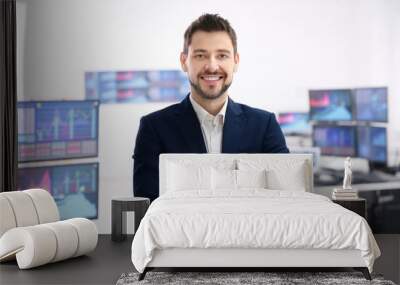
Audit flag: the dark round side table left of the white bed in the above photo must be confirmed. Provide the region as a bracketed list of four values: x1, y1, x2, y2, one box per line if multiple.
[111, 197, 150, 241]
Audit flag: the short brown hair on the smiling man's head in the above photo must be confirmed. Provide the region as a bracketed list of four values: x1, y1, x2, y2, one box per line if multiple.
[183, 14, 237, 54]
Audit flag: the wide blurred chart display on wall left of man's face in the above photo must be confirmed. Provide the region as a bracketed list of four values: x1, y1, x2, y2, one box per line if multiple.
[85, 70, 190, 103]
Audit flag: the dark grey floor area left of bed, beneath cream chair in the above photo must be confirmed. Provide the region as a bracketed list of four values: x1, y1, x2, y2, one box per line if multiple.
[0, 235, 134, 285]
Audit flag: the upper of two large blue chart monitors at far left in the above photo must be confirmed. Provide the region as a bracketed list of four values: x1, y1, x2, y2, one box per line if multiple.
[18, 101, 99, 162]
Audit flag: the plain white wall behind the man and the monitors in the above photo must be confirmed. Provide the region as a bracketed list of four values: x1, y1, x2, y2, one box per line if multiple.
[17, 0, 400, 233]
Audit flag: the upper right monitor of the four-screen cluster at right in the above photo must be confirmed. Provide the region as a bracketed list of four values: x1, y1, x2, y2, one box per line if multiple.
[353, 87, 388, 122]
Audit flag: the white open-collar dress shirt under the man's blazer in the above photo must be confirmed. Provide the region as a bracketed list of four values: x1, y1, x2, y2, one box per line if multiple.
[189, 94, 228, 153]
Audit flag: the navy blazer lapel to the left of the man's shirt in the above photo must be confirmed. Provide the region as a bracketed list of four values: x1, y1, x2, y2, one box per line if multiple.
[176, 95, 207, 153]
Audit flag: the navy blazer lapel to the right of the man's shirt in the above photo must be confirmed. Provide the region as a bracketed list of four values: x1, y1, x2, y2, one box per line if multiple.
[222, 98, 247, 153]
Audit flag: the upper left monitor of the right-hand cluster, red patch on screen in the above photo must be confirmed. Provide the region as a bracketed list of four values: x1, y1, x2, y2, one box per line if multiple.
[309, 89, 353, 122]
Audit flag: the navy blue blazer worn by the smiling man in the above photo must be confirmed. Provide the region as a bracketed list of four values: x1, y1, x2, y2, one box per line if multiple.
[133, 95, 289, 201]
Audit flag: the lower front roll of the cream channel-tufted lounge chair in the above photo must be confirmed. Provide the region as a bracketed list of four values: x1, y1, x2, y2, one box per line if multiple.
[0, 218, 98, 269]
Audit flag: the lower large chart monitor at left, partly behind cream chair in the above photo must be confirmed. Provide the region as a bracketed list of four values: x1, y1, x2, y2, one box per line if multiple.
[17, 163, 99, 220]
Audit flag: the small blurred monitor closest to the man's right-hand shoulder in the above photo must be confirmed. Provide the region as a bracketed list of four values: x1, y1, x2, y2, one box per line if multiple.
[278, 112, 311, 135]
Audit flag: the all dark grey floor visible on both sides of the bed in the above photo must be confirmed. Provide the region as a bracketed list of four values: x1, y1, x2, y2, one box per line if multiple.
[0, 235, 400, 285]
